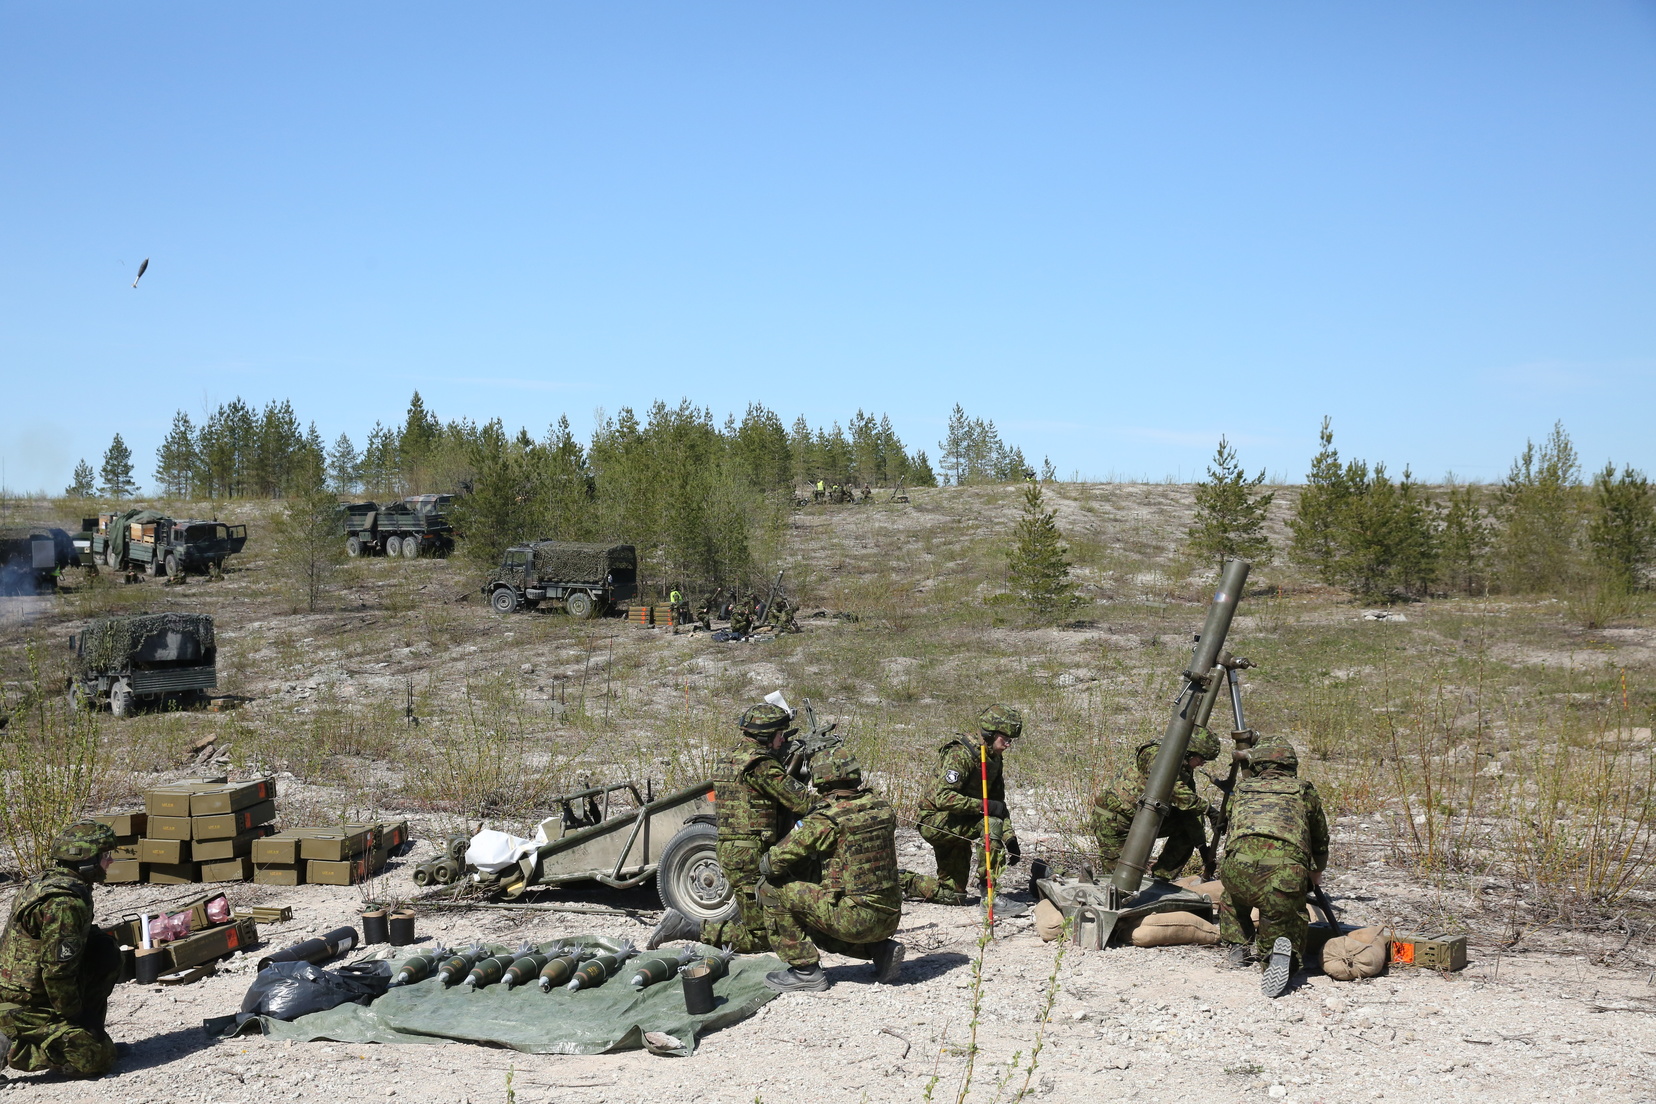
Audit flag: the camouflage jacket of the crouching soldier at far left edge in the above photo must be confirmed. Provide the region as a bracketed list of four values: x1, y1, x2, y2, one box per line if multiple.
[0, 869, 93, 1018]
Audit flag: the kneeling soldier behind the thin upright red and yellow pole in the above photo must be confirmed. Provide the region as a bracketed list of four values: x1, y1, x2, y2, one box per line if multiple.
[901, 705, 1023, 905]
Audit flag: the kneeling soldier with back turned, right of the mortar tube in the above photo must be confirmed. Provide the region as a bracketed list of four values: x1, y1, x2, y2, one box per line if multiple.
[1219, 738, 1328, 996]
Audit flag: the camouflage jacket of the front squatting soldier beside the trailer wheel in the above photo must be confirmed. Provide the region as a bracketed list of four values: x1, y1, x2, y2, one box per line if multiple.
[770, 790, 903, 912]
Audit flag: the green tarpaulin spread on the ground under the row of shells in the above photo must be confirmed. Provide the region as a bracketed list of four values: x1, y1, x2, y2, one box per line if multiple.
[260, 938, 782, 1056]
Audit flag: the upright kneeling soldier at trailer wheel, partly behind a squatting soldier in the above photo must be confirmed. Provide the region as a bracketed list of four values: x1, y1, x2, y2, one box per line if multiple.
[644, 702, 811, 955]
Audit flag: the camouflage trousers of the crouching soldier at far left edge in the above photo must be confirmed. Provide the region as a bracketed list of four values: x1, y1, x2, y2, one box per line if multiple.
[0, 929, 121, 1078]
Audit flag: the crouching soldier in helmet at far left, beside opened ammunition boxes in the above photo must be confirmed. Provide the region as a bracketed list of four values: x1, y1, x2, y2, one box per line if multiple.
[0, 821, 121, 1078]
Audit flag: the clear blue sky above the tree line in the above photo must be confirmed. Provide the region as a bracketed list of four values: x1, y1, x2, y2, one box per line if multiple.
[0, 0, 1656, 492]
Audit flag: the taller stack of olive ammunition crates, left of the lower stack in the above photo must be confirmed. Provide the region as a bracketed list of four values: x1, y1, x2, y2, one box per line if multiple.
[94, 778, 277, 886]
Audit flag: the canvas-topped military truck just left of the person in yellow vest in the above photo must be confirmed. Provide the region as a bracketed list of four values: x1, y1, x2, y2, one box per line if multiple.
[484, 540, 638, 621]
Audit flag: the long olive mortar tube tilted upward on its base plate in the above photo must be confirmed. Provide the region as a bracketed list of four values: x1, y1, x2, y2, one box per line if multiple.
[1110, 559, 1252, 900]
